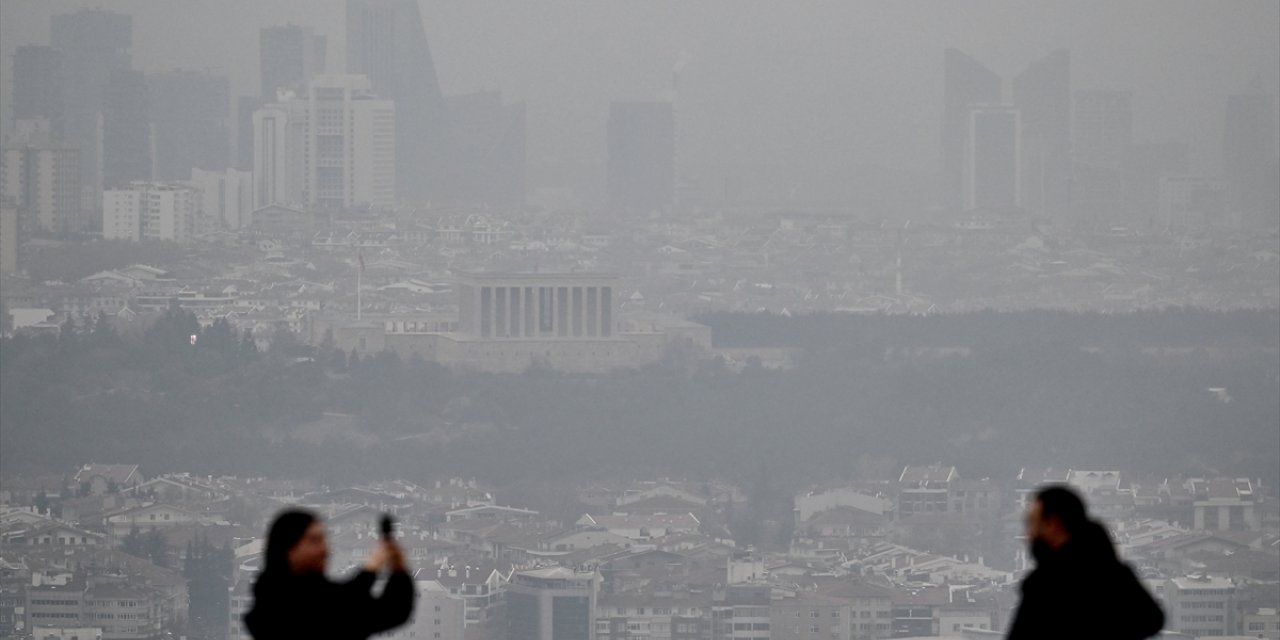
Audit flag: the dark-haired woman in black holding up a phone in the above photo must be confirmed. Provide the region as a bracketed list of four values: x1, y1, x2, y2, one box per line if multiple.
[244, 509, 415, 640]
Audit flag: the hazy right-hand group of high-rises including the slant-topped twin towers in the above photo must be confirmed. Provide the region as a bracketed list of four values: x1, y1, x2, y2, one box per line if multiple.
[942, 49, 1280, 230]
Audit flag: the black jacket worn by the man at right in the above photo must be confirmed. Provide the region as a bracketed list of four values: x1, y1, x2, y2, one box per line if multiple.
[1009, 522, 1165, 640]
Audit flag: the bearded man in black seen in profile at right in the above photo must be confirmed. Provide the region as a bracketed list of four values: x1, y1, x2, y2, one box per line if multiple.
[1009, 485, 1165, 640]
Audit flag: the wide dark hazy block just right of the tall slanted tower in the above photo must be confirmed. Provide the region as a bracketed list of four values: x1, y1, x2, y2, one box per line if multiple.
[442, 91, 525, 206]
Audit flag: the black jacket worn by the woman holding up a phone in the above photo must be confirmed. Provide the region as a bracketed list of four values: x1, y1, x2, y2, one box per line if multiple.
[244, 571, 415, 640]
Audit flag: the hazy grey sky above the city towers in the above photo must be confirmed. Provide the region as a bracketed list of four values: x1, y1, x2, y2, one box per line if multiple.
[0, 0, 1280, 189]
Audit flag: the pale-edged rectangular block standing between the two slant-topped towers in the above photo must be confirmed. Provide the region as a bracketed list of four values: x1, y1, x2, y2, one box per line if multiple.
[964, 105, 1023, 211]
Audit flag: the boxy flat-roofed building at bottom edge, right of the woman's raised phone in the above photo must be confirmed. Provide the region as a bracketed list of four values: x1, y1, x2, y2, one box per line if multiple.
[507, 567, 599, 640]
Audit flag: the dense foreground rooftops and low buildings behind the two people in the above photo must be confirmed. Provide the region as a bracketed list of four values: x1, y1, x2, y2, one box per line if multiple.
[0, 465, 1280, 640]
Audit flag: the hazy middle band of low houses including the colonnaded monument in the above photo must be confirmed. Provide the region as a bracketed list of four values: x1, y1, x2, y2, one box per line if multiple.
[10, 202, 1280, 371]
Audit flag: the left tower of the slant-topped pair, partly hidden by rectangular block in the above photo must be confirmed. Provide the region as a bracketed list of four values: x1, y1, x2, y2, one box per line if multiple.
[942, 49, 1004, 210]
